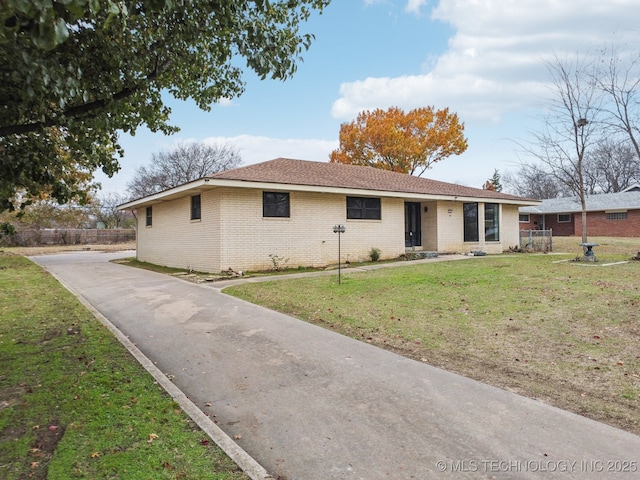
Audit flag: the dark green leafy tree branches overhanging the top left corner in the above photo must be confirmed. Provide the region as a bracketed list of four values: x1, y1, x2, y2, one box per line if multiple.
[0, 0, 330, 210]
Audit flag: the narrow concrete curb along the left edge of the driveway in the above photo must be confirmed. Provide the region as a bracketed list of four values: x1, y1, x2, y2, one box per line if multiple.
[43, 267, 274, 480]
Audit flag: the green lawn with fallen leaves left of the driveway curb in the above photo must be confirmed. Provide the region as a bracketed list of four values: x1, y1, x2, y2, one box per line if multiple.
[0, 253, 247, 480]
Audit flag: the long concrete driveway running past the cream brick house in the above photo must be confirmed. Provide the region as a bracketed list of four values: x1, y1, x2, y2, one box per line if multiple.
[32, 252, 640, 480]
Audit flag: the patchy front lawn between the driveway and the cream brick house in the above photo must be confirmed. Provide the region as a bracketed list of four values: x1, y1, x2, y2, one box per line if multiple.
[224, 251, 640, 434]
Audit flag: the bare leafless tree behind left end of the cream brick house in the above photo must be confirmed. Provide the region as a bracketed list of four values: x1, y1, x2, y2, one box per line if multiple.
[127, 143, 242, 198]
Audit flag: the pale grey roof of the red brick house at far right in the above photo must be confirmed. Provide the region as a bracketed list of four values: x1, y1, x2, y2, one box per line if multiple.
[520, 191, 640, 214]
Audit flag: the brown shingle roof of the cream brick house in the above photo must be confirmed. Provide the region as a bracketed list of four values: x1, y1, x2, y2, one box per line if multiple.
[207, 158, 538, 203]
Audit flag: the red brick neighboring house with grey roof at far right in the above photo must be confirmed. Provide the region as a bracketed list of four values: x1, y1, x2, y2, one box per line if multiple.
[520, 185, 640, 237]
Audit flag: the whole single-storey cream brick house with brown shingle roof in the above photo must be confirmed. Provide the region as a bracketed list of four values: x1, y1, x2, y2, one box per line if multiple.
[119, 158, 538, 272]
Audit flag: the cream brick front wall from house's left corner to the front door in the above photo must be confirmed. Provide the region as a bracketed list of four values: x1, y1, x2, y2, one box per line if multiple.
[220, 189, 404, 270]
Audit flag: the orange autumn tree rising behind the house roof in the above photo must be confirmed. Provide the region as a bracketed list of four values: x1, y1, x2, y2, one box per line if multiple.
[330, 107, 467, 176]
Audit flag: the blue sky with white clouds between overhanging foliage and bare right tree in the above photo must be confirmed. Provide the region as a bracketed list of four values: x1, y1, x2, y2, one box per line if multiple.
[96, 0, 640, 194]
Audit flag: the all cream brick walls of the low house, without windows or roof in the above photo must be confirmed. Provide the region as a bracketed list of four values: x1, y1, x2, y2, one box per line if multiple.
[136, 188, 518, 272]
